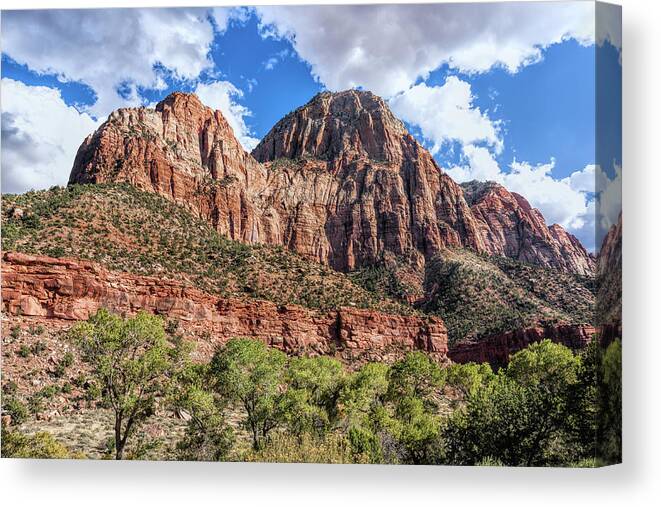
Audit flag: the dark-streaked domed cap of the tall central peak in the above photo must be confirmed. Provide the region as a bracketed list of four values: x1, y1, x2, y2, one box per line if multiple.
[253, 90, 415, 162]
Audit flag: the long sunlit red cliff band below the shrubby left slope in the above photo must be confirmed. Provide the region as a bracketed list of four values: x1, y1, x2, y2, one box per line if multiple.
[2, 252, 447, 365]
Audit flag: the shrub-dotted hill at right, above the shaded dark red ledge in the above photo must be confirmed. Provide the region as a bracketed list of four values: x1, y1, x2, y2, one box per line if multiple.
[422, 250, 594, 343]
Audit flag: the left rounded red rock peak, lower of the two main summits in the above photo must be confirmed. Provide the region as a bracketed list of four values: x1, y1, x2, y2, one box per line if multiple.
[69, 93, 274, 242]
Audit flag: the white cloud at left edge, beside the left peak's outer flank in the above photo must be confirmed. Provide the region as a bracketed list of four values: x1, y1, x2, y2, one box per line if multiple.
[2, 78, 98, 193]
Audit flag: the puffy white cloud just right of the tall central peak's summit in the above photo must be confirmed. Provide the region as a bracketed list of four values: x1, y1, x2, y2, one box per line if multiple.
[389, 76, 503, 153]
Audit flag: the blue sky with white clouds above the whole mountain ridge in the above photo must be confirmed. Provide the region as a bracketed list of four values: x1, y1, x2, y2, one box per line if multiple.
[1, 2, 621, 249]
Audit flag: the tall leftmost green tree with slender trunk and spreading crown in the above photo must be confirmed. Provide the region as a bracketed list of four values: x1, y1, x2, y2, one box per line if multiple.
[68, 309, 189, 459]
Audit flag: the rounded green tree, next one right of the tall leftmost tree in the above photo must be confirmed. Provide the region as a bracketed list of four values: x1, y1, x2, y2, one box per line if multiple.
[210, 339, 286, 450]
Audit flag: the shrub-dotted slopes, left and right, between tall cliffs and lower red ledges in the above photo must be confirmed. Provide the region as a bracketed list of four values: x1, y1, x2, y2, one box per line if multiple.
[2, 184, 593, 354]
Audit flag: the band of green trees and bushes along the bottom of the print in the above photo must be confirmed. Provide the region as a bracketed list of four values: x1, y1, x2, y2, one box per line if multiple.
[2, 312, 621, 466]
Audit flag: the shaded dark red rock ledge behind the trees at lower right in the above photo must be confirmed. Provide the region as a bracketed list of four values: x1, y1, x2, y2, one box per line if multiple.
[448, 324, 597, 366]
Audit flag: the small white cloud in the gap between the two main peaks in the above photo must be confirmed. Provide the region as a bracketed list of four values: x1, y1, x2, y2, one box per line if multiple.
[195, 81, 259, 151]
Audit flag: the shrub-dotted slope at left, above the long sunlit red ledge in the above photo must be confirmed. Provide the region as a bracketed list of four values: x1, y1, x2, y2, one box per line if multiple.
[2, 184, 413, 313]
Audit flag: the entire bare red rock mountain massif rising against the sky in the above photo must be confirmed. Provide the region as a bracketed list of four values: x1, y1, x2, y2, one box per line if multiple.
[70, 90, 594, 274]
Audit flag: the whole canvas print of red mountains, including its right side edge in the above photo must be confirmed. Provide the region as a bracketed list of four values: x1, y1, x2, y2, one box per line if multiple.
[1, 1, 622, 467]
